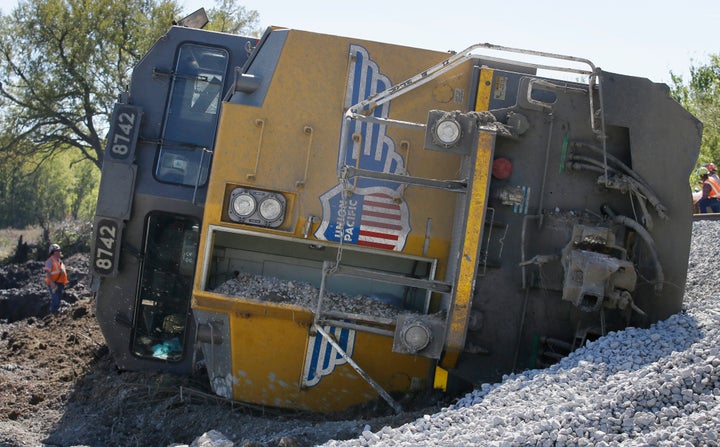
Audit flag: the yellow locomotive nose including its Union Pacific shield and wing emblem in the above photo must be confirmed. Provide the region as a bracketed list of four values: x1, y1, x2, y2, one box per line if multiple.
[193, 30, 491, 411]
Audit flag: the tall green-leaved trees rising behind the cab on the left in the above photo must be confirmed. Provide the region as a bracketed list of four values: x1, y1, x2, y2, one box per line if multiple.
[0, 0, 257, 173]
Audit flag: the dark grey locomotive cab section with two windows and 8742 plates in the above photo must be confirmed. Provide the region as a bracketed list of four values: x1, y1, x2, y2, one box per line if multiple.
[91, 26, 256, 373]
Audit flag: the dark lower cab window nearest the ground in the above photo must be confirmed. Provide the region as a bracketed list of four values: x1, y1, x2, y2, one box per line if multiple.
[131, 213, 200, 362]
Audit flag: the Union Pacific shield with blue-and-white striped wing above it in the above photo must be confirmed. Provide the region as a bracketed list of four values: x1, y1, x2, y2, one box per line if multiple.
[315, 45, 410, 251]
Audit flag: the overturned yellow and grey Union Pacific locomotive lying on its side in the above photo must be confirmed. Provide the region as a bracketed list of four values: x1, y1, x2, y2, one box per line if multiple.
[92, 13, 702, 412]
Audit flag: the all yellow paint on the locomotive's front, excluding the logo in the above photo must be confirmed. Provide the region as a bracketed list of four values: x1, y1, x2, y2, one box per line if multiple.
[193, 30, 491, 412]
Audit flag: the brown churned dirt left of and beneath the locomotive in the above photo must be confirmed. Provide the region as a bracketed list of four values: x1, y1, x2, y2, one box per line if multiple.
[0, 255, 438, 447]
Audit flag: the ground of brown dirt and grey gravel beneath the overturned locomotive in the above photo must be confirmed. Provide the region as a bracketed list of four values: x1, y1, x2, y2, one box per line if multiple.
[0, 221, 720, 447]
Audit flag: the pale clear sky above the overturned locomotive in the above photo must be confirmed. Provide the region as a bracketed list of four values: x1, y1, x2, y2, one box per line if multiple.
[0, 0, 720, 83]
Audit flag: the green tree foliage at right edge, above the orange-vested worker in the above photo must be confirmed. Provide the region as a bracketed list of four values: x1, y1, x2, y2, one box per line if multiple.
[671, 55, 720, 186]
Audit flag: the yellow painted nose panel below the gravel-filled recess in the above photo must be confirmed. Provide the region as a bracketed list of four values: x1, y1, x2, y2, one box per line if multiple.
[193, 293, 431, 412]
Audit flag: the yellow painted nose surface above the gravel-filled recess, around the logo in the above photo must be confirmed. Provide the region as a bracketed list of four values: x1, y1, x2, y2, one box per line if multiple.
[204, 30, 471, 258]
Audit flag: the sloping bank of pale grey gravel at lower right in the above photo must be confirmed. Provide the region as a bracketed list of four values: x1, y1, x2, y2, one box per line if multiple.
[323, 220, 720, 447]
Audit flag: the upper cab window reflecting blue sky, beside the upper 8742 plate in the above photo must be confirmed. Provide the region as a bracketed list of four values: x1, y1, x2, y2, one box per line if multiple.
[155, 44, 228, 186]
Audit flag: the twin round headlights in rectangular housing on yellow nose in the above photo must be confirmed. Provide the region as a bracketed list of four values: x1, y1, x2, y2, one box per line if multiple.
[227, 188, 287, 228]
